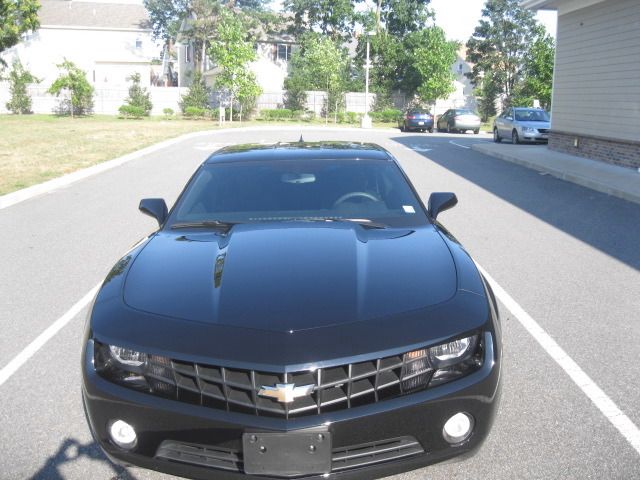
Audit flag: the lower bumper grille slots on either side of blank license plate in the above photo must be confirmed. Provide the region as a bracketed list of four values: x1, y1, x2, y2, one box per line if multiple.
[156, 436, 424, 472]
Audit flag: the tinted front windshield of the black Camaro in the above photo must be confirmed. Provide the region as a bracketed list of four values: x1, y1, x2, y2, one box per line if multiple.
[167, 160, 428, 228]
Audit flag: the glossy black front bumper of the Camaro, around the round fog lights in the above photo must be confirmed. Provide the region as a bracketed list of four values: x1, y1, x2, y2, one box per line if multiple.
[83, 333, 500, 480]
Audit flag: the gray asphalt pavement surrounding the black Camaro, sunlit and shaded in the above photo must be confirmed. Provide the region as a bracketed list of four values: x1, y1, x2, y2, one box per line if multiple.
[0, 129, 640, 480]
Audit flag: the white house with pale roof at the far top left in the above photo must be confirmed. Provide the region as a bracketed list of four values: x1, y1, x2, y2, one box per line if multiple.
[2, 0, 159, 88]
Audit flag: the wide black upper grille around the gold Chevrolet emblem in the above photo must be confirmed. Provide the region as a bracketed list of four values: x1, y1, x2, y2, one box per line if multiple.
[95, 341, 483, 419]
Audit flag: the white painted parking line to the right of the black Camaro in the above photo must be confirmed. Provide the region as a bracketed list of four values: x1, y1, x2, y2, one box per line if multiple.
[476, 264, 640, 454]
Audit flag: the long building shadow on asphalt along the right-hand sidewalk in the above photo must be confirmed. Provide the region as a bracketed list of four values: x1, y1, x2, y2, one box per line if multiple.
[390, 135, 640, 270]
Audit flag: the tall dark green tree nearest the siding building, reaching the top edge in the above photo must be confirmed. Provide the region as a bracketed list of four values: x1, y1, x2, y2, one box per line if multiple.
[467, 0, 537, 106]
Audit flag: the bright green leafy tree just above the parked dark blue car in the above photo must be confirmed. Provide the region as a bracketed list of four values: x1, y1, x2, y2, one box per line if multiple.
[404, 26, 458, 104]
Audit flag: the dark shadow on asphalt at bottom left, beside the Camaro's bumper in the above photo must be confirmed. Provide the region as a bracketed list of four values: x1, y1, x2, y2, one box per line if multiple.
[31, 438, 135, 480]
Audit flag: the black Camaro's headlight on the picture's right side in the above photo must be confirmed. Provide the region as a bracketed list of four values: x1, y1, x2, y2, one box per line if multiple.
[401, 334, 482, 392]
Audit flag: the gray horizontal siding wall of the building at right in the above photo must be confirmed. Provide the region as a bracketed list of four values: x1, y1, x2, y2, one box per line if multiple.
[551, 0, 640, 141]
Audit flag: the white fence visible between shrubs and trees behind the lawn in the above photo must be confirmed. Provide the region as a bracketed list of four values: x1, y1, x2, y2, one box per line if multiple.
[0, 82, 375, 116]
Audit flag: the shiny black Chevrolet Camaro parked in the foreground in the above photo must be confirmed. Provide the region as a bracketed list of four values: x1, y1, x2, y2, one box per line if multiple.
[82, 142, 502, 479]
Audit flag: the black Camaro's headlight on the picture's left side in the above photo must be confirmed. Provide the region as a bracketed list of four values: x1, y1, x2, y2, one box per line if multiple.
[94, 342, 176, 397]
